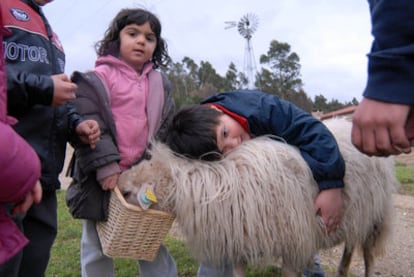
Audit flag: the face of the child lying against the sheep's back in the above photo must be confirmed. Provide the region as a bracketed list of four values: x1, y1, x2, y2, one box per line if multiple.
[216, 114, 250, 154]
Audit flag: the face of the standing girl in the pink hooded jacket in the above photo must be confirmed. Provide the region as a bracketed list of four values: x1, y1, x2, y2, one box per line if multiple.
[119, 22, 157, 73]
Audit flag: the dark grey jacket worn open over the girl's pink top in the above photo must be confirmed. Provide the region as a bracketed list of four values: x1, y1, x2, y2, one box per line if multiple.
[66, 72, 175, 221]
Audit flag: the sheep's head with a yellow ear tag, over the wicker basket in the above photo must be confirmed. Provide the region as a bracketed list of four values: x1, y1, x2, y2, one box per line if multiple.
[118, 151, 172, 212]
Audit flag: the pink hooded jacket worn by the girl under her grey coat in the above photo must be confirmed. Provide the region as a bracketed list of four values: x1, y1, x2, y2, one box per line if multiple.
[95, 56, 164, 170]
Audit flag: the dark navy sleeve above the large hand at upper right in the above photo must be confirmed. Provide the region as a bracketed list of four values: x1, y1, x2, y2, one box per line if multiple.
[364, 0, 414, 105]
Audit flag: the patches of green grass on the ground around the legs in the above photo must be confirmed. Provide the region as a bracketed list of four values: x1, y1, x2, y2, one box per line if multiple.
[46, 163, 414, 277]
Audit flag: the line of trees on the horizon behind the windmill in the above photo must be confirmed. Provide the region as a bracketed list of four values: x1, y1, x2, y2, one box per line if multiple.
[163, 40, 358, 110]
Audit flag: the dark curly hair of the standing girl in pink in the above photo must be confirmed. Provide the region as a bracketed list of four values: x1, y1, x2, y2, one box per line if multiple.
[95, 9, 171, 68]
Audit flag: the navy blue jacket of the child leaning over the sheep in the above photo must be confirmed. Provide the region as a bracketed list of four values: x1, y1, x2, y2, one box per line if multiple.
[201, 90, 345, 190]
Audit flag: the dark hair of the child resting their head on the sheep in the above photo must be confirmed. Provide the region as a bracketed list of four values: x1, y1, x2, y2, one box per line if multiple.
[166, 105, 222, 161]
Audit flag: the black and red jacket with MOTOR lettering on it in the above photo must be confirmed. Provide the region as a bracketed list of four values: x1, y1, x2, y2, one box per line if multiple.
[0, 0, 81, 190]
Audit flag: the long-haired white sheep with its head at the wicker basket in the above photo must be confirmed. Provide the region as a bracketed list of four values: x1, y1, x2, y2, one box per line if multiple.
[119, 119, 398, 276]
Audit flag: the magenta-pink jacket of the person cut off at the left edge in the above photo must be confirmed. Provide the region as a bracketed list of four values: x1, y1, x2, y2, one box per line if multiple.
[0, 14, 40, 264]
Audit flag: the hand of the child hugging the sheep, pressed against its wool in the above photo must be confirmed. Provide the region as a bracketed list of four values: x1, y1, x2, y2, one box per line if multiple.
[314, 188, 344, 235]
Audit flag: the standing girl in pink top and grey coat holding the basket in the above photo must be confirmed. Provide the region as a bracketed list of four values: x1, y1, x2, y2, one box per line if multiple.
[66, 9, 178, 277]
